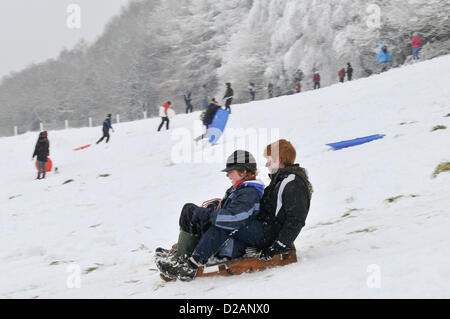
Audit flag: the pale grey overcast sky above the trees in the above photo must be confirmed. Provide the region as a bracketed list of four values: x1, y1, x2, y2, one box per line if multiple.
[0, 0, 129, 77]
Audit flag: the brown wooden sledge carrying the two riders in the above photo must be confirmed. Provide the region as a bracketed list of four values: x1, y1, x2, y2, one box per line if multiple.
[160, 247, 297, 281]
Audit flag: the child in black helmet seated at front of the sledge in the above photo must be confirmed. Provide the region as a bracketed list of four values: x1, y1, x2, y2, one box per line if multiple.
[157, 150, 264, 281]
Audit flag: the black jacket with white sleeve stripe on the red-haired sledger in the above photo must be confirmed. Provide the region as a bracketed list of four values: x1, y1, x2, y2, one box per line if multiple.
[257, 165, 313, 246]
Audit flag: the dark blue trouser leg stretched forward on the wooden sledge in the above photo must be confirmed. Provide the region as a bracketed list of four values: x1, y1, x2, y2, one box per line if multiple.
[192, 220, 264, 265]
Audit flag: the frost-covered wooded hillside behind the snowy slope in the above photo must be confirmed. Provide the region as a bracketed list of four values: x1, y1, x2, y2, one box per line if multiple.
[0, 0, 450, 136]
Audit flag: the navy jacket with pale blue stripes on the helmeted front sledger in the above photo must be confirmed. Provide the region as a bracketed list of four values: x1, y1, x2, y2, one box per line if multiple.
[192, 180, 264, 230]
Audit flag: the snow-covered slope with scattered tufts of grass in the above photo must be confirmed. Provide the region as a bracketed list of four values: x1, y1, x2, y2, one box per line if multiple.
[0, 56, 450, 298]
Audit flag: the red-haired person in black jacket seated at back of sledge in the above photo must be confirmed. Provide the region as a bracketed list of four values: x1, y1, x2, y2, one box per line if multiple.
[257, 140, 313, 260]
